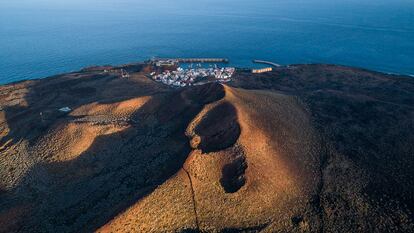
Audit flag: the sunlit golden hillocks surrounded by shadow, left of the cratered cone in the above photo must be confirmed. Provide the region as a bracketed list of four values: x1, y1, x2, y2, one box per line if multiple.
[32, 97, 151, 162]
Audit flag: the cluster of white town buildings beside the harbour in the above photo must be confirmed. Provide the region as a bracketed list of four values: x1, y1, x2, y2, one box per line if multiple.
[151, 67, 235, 87]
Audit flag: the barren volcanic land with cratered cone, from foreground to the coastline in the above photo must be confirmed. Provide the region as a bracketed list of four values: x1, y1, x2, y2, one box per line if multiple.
[0, 64, 414, 232]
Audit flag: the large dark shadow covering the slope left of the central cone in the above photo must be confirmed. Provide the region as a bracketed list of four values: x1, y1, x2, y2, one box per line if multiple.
[0, 68, 224, 232]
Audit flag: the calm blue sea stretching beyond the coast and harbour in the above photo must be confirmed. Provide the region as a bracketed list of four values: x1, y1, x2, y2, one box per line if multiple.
[0, 0, 414, 83]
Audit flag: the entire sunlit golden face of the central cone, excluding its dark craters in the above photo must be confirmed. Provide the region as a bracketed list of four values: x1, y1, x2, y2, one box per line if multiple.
[100, 84, 319, 232]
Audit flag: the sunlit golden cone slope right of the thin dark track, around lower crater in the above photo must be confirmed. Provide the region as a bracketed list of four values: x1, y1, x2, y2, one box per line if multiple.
[187, 87, 318, 231]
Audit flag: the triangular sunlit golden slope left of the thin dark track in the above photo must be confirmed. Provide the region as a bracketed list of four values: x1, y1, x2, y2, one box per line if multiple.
[97, 170, 197, 233]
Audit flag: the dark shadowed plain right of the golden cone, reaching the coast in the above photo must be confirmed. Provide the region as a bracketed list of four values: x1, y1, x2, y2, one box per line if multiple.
[230, 64, 414, 221]
